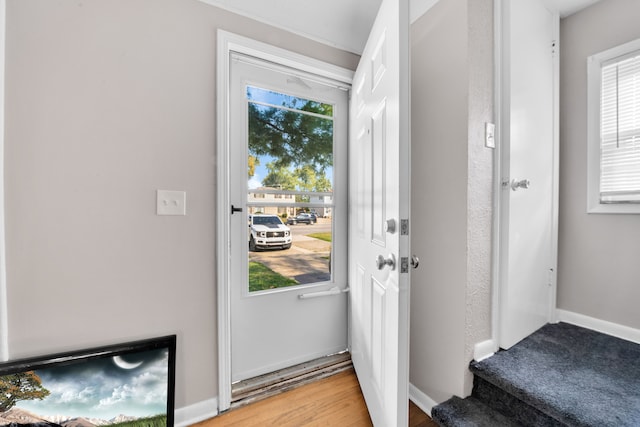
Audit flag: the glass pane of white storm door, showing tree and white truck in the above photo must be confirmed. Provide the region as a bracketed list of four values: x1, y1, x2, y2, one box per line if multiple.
[246, 86, 334, 292]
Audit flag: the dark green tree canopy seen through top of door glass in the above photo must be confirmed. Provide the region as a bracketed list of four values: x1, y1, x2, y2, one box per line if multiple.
[249, 96, 333, 176]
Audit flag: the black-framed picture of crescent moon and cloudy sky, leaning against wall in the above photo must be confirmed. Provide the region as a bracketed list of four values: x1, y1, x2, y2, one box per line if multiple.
[0, 335, 176, 427]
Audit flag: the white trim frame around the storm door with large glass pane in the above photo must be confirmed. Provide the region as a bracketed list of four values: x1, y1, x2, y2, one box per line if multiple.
[216, 30, 353, 411]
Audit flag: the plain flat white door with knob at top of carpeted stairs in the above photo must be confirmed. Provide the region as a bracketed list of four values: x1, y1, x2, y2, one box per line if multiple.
[499, 0, 558, 348]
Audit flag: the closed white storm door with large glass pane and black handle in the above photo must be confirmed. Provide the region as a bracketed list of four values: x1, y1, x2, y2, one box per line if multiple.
[229, 53, 348, 382]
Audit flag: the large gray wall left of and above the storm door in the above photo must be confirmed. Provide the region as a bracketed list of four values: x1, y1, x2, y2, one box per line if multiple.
[5, 0, 358, 408]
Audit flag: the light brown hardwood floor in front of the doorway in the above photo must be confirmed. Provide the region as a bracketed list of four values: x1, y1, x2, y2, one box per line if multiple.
[193, 369, 437, 427]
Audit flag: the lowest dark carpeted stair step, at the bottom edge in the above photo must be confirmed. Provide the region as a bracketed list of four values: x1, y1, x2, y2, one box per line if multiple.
[431, 397, 520, 427]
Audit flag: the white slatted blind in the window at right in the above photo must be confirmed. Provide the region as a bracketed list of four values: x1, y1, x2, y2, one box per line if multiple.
[600, 51, 640, 203]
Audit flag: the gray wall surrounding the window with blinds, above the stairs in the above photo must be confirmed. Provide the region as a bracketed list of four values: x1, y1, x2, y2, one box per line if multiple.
[558, 0, 640, 328]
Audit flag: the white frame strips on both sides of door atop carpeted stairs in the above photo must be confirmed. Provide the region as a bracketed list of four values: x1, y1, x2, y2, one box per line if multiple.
[490, 0, 560, 357]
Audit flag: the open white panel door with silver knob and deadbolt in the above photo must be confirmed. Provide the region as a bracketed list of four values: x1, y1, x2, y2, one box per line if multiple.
[349, 0, 411, 426]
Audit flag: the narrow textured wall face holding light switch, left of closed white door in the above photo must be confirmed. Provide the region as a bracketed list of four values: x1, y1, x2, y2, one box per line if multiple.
[465, 0, 494, 392]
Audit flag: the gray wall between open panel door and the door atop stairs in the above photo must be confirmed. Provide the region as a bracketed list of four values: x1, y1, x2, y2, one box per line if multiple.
[410, 0, 493, 401]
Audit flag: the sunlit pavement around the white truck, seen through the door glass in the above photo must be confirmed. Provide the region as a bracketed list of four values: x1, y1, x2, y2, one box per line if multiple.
[249, 218, 331, 284]
